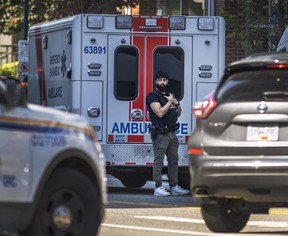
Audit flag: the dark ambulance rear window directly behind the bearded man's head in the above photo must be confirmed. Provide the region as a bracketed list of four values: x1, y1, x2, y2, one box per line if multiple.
[153, 46, 184, 100]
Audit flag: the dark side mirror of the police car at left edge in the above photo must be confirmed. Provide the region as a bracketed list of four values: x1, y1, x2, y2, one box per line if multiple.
[0, 80, 26, 108]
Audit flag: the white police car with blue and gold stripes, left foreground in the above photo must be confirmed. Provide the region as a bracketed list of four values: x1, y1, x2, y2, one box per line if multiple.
[0, 81, 107, 236]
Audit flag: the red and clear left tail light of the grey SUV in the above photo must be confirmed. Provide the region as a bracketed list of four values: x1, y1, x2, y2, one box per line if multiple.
[193, 96, 217, 119]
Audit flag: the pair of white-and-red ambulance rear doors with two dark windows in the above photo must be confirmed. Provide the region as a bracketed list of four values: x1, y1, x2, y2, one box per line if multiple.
[107, 34, 192, 148]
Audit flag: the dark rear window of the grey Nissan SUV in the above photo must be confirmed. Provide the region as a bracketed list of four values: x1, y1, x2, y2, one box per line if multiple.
[216, 70, 288, 103]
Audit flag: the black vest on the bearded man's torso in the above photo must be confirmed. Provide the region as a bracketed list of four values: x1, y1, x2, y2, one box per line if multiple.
[146, 91, 178, 127]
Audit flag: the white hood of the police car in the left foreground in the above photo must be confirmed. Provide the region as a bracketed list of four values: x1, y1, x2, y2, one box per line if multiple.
[27, 103, 89, 128]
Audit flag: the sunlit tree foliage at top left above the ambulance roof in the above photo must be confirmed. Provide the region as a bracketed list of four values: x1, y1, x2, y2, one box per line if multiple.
[0, 0, 139, 35]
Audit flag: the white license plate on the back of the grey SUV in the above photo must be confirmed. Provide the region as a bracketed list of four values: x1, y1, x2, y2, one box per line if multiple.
[247, 125, 279, 141]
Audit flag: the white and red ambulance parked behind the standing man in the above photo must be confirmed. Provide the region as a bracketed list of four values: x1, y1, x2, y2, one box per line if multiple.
[28, 14, 225, 188]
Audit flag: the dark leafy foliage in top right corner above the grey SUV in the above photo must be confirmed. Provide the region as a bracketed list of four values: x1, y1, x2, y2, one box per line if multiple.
[224, 0, 288, 56]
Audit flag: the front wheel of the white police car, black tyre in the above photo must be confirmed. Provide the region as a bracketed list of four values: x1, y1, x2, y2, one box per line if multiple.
[20, 168, 100, 236]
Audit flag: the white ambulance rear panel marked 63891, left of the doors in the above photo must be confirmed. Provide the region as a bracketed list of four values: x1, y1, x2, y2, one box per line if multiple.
[79, 29, 107, 141]
